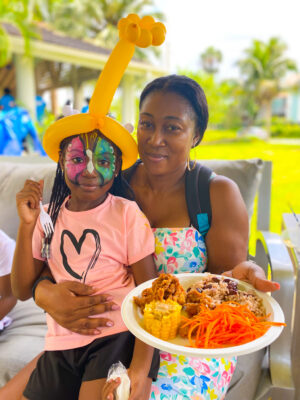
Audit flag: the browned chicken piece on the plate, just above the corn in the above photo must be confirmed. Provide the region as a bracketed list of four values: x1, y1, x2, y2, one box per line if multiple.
[134, 274, 186, 313]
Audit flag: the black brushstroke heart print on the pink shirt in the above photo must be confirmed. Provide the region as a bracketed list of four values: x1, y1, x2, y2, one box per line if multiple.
[60, 229, 101, 283]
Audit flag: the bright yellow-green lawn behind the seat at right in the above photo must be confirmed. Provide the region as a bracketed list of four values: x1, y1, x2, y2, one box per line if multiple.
[191, 131, 300, 250]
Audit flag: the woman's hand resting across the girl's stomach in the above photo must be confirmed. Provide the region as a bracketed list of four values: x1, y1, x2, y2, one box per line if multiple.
[35, 280, 119, 335]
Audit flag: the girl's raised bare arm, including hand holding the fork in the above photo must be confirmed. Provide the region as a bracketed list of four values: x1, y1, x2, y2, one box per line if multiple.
[11, 180, 43, 300]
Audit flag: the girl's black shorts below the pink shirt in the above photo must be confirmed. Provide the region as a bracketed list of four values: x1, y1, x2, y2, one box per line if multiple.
[24, 331, 159, 400]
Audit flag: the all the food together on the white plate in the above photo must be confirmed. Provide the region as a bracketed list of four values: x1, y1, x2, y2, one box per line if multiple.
[134, 274, 285, 349]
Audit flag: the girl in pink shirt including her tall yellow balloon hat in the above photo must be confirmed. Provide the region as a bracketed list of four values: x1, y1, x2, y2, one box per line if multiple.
[12, 14, 165, 400]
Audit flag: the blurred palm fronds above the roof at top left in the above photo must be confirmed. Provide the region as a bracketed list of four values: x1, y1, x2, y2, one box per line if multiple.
[0, 0, 163, 66]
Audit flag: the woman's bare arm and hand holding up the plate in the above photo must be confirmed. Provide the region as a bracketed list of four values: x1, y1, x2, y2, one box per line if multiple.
[205, 176, 279, 291]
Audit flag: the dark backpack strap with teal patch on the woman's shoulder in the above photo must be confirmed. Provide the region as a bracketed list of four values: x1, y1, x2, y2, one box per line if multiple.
[185, 162, 212, 237]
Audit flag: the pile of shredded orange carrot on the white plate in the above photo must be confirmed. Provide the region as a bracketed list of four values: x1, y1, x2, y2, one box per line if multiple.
[181, 302, 286, 349]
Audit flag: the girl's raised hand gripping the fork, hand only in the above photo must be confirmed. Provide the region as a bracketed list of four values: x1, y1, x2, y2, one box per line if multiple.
[16, 179, 44, 225]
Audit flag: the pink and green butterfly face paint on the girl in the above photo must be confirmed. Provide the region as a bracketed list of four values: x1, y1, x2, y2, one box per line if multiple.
[65, 134, 116, 186]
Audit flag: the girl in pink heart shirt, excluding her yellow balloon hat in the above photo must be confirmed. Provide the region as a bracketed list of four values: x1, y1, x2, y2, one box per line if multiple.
[13, 131, 158, 400]
